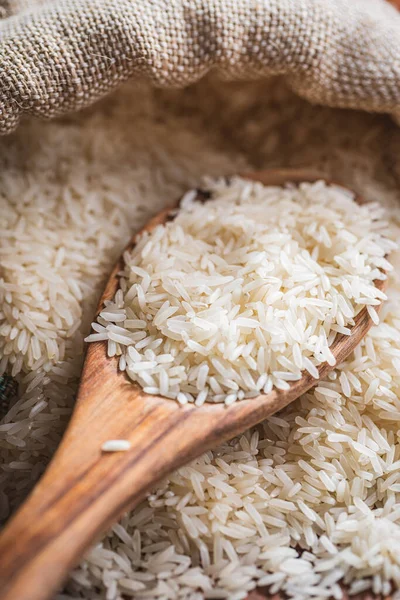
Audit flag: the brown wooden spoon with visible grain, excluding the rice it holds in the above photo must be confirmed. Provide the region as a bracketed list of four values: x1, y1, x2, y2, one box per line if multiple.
[0, 170, 385, 600]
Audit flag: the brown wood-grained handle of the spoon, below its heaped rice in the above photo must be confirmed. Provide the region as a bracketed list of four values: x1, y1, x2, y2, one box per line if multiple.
[0, 382, 197, 600]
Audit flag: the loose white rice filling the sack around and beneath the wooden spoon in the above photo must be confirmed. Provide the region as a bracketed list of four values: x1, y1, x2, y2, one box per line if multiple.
[0, 81, 400, 600]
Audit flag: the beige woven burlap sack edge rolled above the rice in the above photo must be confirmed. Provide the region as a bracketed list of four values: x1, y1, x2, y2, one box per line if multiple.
[0, 0, 400, 133]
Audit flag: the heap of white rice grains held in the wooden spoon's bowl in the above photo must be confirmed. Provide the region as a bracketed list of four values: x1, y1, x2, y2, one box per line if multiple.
[86, 177, 396, 406]
